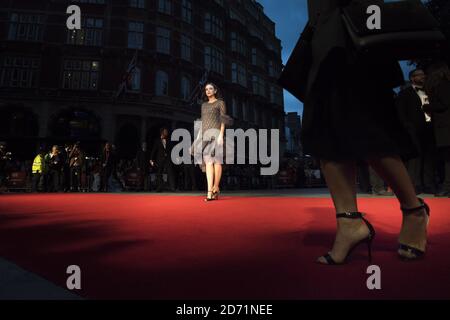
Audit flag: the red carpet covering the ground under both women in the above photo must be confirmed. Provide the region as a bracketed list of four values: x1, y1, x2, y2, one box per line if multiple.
[0, 194, 450, 299]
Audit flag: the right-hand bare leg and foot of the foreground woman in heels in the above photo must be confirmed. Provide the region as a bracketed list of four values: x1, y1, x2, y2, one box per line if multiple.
[368, 156, 428, 255]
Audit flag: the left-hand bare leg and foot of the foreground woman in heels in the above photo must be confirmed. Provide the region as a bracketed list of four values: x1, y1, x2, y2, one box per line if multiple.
[318, 160, 369, 264]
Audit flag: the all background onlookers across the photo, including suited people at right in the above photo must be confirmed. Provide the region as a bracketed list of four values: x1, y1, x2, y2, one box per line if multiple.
[0, 64, 450, 197]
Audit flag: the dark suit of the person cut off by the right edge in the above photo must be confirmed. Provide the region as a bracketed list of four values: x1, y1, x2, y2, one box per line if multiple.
[425, 80, 450, 193]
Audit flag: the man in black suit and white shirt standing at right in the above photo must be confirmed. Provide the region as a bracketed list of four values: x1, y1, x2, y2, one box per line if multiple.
[396, 69, 436, 194]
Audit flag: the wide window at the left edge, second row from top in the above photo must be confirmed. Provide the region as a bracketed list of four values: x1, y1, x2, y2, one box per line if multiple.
[0, 57, 39, 88]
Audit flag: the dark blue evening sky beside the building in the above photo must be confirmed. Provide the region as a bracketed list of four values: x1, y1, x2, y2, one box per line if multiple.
[258, 0, 411, 114]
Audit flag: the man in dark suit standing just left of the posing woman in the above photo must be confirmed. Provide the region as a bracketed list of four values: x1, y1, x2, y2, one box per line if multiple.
[150, 128, 175, 192]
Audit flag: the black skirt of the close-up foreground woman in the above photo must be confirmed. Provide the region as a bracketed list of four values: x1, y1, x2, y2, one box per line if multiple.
[301, 50, 418, 161]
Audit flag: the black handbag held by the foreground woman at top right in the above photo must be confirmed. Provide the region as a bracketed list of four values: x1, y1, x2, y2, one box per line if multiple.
[342, 0, 446, 60]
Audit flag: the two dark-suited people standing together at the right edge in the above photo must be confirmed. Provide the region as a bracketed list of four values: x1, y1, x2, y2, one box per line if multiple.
[396, 63, 450, 197]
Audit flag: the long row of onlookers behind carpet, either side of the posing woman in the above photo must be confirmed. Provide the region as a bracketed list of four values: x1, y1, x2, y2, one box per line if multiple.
[0, 128, 275, 192]
